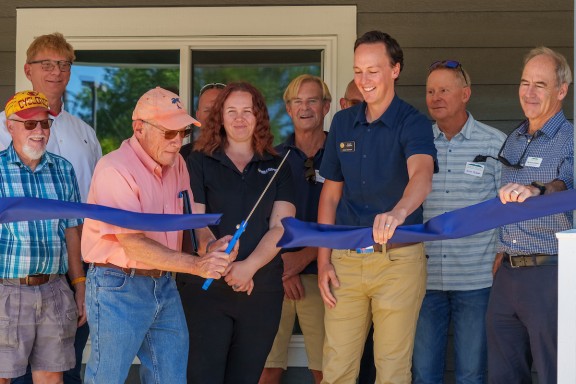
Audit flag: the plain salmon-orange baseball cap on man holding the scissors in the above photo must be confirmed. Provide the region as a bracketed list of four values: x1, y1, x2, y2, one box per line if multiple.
[132, 87, 201, 130]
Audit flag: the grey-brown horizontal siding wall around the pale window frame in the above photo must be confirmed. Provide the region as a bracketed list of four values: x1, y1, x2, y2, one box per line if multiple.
[0, 0, 574, 131]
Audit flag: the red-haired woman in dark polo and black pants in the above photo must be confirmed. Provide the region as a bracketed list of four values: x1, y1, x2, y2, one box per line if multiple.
[181, 83, 295, 384]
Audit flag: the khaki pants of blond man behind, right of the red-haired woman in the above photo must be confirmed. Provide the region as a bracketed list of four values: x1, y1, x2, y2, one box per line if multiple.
[265, 275, 324, 371]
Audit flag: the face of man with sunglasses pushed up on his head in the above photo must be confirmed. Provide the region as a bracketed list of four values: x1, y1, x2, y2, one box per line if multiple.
[426, 69, 470, 126]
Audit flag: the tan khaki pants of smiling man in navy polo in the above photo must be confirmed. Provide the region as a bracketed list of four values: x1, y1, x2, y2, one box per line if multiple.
[322, 243, 426, 384]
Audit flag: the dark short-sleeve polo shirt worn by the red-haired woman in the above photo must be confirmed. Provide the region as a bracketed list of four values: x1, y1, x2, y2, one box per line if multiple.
[186, 150, 294, 291]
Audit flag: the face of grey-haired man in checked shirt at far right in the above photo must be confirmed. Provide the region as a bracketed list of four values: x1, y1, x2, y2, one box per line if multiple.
[518, 55, 568, 129]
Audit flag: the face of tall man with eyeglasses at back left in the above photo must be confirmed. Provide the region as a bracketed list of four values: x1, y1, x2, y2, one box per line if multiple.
[24, 50, 70, 100]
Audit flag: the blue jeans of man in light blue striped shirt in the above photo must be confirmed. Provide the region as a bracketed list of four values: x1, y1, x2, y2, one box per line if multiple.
[412, 288, 490, 384]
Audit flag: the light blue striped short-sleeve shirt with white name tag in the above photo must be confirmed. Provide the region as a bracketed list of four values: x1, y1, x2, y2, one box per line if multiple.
[424, 114, 506, 291]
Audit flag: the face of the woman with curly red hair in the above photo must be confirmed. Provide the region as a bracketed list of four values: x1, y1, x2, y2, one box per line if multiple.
[222, 91, 256, 143]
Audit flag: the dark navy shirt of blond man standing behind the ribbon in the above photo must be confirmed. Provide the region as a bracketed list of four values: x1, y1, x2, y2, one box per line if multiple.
[276, 134, 324, 274]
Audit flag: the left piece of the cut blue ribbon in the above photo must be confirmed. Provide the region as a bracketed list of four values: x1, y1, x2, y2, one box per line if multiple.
[0, 197, 222, 232]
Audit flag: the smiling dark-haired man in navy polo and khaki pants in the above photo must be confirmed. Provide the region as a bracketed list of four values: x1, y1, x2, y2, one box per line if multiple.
[318, 31, 436, 383]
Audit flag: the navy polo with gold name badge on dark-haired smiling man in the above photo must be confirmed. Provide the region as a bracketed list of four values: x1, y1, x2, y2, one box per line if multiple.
[320, 96, 436, 226]
